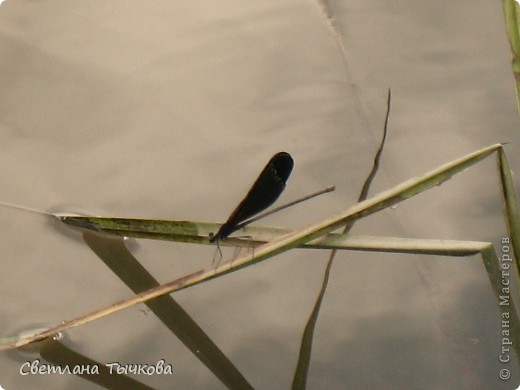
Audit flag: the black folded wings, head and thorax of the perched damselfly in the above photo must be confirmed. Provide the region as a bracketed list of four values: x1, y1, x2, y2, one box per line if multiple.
[209, 152, 294, 242]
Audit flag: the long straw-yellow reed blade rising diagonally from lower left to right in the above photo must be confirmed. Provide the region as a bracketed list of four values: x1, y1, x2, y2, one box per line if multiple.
[0, 144, 518, 349]
